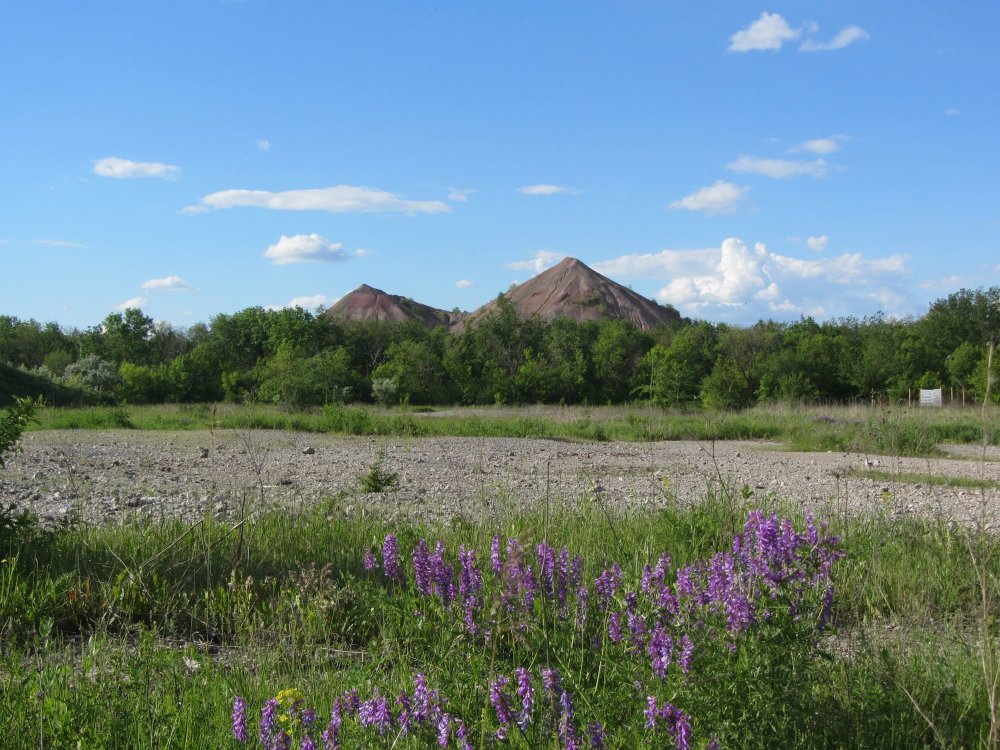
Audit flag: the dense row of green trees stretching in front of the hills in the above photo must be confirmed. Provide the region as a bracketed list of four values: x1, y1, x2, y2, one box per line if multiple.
[0, 287, 1000, 409]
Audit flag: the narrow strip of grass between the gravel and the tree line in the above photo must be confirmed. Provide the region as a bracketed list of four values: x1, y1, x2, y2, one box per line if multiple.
[29, 404, 1000, 456]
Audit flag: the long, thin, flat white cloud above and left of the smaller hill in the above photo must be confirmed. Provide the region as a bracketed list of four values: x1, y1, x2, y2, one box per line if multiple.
[191, 185, 451, 214]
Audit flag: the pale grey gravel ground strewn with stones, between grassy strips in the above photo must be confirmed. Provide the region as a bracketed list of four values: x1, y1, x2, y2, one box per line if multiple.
[0, 430, 1000, 527]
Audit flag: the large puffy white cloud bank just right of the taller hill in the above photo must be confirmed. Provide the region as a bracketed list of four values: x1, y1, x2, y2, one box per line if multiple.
[594, 237, 913, 323]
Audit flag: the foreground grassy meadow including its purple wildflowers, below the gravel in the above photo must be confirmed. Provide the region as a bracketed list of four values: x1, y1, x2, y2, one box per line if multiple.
[0, 484, 1000, 748]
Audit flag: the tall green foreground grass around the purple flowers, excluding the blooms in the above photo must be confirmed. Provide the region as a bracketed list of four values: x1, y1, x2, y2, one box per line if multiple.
[0, 494, 1000, 748]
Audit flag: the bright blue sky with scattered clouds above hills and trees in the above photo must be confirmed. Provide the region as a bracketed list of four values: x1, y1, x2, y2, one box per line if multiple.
[0, 0, 1000, 327]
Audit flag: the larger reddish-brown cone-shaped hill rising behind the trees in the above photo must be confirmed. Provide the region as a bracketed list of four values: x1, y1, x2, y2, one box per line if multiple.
[453, 258, 680, 330]
